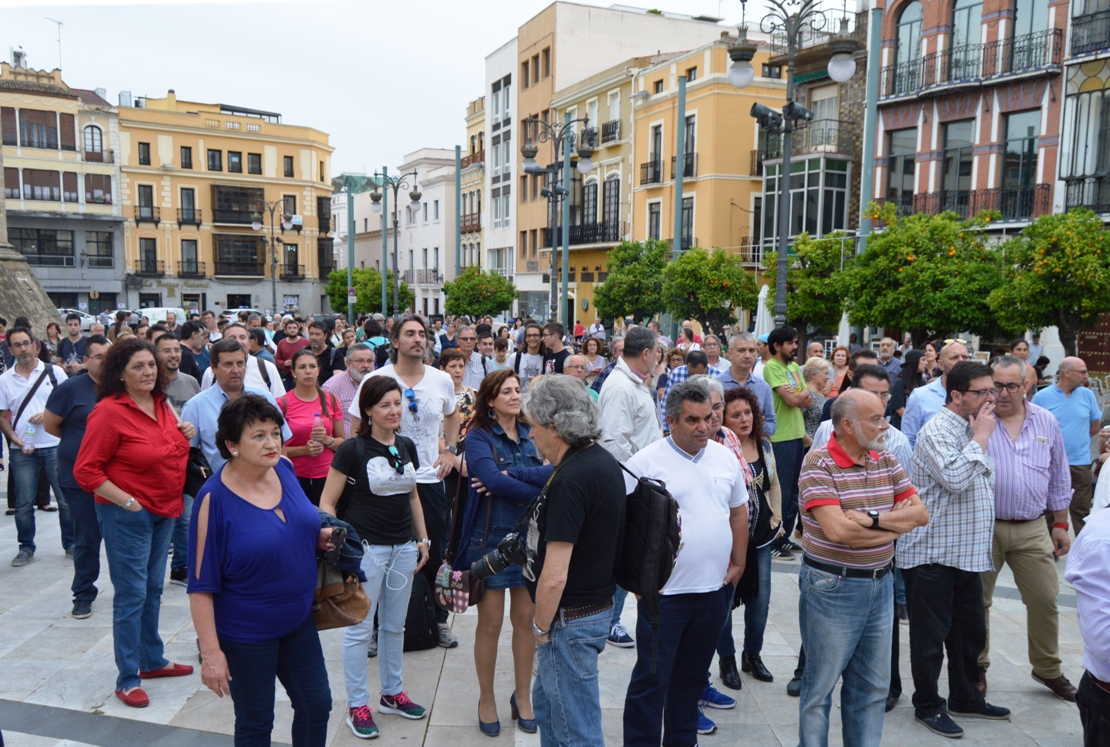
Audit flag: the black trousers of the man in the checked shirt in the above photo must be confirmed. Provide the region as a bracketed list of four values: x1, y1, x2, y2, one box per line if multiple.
[902, 563, 987, 718]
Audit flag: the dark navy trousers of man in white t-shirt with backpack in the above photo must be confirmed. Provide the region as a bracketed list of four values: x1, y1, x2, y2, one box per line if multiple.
[624, 586, 734, 747]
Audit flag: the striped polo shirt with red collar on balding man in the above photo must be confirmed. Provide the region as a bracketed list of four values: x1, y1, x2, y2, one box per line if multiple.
[798, 435, 917, 568]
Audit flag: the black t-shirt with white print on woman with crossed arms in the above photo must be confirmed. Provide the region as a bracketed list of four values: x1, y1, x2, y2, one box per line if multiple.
[332, 435, 420, 545]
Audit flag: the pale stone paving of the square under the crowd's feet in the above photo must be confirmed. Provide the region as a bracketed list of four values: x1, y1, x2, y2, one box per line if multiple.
[0, 503, 1082, 747]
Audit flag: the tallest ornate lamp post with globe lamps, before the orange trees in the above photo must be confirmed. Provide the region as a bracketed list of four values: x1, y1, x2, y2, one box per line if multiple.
[728, 0, 858, 327]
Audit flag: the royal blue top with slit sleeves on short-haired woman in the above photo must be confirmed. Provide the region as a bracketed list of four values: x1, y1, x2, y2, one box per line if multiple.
[189, 460, 320, 643]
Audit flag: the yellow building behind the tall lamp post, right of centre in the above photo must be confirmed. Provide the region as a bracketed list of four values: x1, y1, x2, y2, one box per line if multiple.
[632, 33, 786, 267]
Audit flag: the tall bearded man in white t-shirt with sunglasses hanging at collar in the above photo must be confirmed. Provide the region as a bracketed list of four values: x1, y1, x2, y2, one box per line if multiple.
[349, 314, 459, 648]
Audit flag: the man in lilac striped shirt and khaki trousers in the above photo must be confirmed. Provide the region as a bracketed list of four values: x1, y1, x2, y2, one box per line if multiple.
[979, 355, 1076, 703]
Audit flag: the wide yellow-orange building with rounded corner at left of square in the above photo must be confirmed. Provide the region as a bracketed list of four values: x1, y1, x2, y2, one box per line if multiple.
[119, 90, 334, 313]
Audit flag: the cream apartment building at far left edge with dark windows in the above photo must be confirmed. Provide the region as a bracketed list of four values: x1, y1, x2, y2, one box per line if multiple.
[0, 59, 129, 314]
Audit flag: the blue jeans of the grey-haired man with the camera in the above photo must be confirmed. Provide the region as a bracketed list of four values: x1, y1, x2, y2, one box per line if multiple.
[532, 609, 612, 747]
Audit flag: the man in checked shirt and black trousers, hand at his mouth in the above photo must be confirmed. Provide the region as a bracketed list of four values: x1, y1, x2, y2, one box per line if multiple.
[896, 361, 1010, 738]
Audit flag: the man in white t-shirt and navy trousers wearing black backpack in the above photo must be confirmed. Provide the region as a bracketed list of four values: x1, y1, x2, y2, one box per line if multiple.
[621, 382, 748, 747]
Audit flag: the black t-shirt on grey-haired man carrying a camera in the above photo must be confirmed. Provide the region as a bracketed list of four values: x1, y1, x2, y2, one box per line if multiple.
[525, 444, 627, 608]
